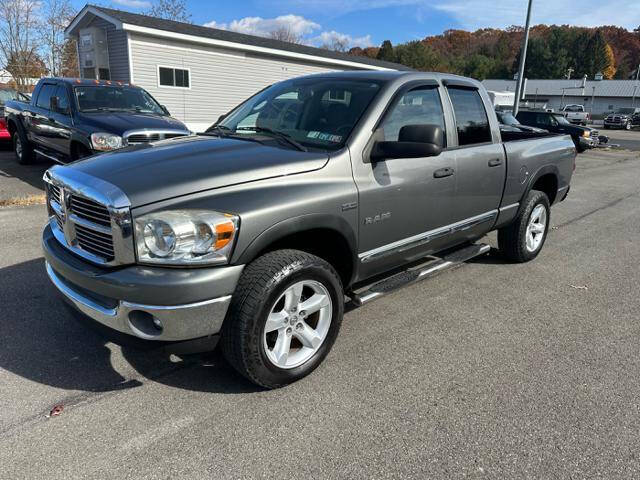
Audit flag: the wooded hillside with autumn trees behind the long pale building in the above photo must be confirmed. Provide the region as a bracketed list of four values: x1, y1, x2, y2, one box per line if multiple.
[364, 25, 640, 80]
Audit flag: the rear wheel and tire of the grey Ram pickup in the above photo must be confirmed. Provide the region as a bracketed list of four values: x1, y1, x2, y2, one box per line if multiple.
[498, 190, 551, 263]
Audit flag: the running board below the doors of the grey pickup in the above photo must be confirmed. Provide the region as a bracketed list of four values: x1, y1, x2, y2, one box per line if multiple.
[349, 243, 491, 307]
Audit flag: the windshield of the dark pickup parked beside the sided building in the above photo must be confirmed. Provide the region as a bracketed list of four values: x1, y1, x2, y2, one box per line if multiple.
[74, 85, 165, 115]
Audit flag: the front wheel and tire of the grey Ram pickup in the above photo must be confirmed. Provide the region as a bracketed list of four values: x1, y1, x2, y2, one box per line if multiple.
[222, 250, 344, 388]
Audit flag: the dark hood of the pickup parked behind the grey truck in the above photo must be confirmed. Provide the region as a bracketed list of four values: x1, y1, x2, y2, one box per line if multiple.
[75, 112, 189, 135]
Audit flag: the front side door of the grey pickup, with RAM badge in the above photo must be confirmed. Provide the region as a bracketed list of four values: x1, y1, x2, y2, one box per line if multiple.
[353, 84, 456, 277]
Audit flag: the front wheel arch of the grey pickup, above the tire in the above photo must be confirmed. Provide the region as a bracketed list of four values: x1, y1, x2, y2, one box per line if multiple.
[234, 214, 357, 287]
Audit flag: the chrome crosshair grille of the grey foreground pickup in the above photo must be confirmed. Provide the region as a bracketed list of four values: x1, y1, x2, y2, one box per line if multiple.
[44, 166, 135, 265]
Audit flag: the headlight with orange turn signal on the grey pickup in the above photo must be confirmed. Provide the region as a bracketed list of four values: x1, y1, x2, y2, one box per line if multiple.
[135, 210, 238, 265]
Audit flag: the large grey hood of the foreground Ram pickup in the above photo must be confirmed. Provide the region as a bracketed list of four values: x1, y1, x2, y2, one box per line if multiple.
[69, 136, 329, 207]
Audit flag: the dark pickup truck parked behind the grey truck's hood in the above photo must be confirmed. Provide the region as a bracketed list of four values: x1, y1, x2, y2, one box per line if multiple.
[5, 78, 191, 164]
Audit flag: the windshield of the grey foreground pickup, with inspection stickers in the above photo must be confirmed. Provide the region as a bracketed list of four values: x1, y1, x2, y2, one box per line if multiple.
[215, 78, 382, 150]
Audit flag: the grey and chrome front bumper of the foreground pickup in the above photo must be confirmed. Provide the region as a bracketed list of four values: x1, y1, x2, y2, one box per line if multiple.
[42, 226, 243, 342]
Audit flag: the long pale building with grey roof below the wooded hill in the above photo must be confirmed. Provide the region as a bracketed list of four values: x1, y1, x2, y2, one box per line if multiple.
[482, 79, 640, 116]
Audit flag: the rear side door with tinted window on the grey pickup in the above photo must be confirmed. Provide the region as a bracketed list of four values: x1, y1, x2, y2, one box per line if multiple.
[446, 83, 506, 242]
